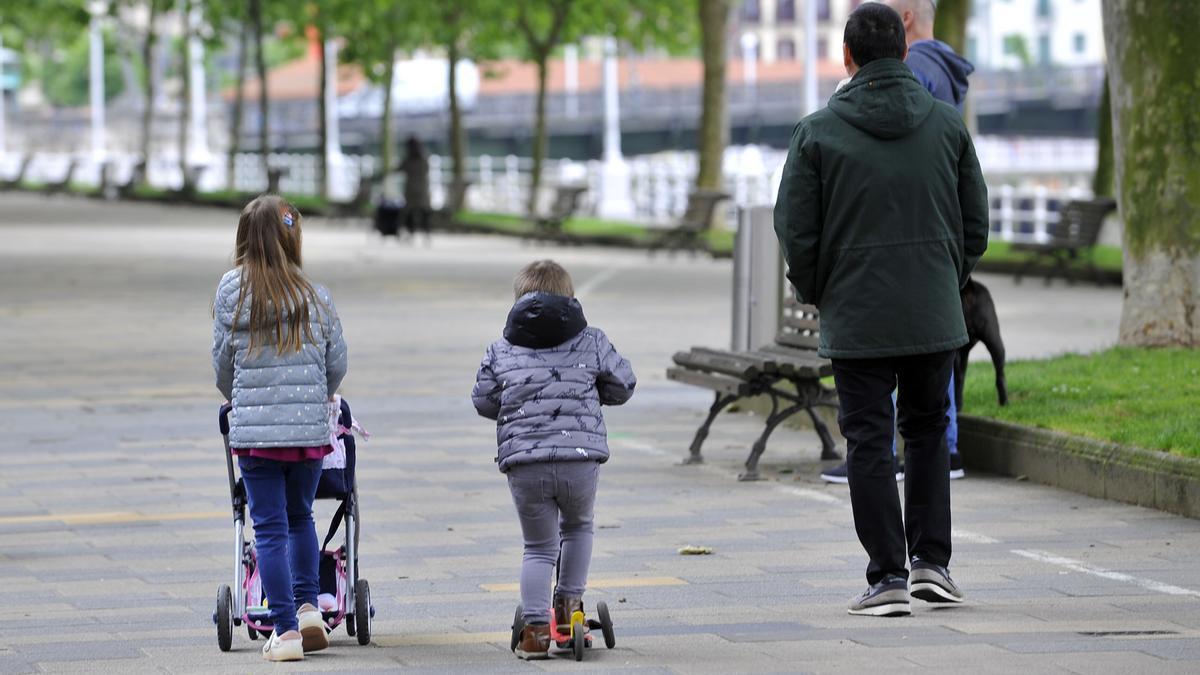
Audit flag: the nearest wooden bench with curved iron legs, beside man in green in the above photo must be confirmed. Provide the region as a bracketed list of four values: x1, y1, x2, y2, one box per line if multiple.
[667, 300, 839, 480]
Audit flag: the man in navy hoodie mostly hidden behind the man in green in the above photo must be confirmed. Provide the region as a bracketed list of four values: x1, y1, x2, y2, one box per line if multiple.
[821, 0, 974, 483]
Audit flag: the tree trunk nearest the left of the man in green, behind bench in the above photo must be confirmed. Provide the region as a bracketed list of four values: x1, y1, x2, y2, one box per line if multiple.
[696, 0, 730, 190]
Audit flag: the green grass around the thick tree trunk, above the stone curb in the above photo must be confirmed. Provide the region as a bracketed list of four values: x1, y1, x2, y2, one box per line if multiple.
[962, 347, 1200, 456]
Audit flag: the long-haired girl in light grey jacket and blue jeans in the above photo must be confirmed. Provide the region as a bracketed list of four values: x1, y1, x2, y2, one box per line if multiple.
[212, 196, 346, 661]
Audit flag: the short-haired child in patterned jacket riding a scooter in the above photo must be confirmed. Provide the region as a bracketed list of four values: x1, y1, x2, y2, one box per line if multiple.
[470, 261, 637, 659]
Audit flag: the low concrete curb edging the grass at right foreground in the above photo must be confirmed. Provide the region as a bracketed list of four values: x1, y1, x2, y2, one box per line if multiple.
[959, 416, 1200, 519]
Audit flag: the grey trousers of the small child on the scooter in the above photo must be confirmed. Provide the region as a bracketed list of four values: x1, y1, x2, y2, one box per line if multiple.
[508, 461, 600, 622]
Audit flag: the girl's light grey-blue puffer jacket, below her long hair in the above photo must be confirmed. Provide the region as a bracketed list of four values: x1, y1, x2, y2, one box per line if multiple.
[212, 269, 346, 448]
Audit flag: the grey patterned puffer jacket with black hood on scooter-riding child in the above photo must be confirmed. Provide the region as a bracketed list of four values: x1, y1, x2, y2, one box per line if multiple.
[470, 293, 637, 472]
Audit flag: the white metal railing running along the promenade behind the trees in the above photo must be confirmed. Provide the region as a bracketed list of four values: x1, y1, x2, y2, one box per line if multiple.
[0, 138, 1096, 241]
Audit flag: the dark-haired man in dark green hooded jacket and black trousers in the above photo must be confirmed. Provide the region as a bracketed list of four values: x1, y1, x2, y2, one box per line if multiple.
[775, 2, 988, 616]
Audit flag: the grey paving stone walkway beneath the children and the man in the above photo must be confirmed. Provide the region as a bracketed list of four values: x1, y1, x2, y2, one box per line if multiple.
[0, 196, 1200, 673]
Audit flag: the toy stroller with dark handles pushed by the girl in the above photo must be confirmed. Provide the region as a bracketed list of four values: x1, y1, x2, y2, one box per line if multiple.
[212, 400, 374, 651]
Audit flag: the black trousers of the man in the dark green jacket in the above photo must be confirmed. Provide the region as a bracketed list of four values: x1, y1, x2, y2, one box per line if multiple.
[833, 352, 954, 584]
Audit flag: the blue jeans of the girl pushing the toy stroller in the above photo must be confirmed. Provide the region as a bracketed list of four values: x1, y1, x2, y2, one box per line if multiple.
[238, 456, 320, 635]
